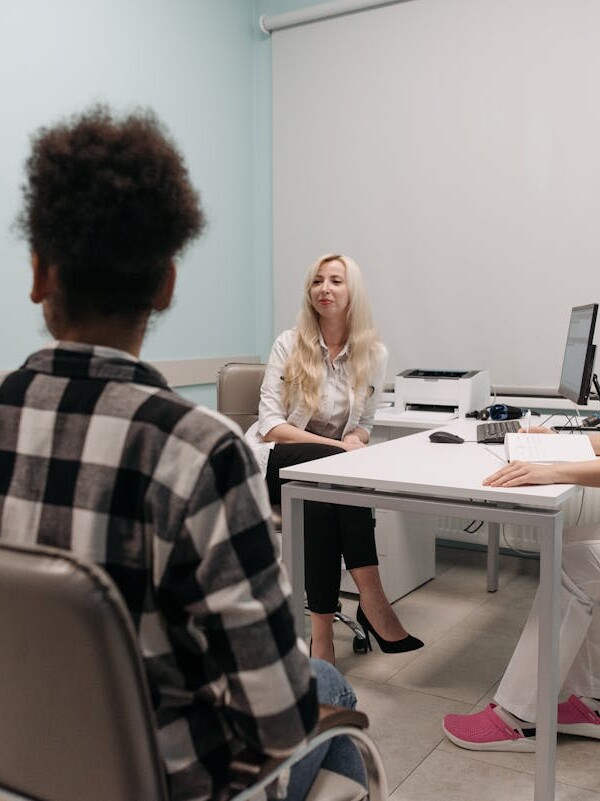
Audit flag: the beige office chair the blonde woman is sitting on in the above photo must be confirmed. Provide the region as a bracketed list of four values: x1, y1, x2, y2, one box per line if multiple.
[217, 362, 367, 654]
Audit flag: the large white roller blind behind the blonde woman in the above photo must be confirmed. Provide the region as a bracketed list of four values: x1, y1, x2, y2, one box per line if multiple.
[273, 0, 600, 388]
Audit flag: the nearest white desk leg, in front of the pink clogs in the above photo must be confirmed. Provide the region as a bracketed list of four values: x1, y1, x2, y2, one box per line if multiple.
[534, 512, 563, 801]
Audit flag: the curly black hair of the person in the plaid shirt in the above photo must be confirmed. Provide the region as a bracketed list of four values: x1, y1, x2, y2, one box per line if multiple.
[17, 105, 205, 321]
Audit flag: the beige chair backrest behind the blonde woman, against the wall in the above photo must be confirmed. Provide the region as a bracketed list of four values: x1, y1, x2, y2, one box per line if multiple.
[217, 362, 266, 431]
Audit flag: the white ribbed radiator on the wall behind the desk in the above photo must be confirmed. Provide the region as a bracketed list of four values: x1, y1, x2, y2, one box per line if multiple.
[428, 487, 600, 551]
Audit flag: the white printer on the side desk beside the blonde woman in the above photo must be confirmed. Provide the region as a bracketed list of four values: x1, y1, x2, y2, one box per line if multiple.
[394, 370, 491, 417]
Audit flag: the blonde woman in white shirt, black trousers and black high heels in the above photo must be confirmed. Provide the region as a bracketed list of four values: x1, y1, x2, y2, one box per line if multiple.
[247, 254, 423, 663]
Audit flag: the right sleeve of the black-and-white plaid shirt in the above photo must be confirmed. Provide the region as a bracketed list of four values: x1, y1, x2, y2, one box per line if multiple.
[160, 432, 318, 756]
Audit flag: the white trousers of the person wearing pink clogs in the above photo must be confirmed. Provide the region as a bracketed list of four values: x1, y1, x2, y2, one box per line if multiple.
[495, 525, 600, 723]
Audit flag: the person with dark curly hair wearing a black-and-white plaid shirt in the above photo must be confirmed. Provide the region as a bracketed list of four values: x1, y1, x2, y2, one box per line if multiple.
[0, 107, 363, 801]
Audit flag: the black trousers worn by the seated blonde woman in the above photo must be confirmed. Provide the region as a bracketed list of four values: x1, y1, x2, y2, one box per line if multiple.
[267, 442, 378, 614]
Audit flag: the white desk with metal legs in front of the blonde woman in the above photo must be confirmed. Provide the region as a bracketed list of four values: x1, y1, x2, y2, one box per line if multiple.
[281, 420, 578, 801]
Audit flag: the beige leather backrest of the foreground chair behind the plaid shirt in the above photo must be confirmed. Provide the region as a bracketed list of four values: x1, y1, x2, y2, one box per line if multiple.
[0, 544, 168, 801]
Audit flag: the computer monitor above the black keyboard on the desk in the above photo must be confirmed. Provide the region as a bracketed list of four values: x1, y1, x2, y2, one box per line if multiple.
[558, 303, 598, 406]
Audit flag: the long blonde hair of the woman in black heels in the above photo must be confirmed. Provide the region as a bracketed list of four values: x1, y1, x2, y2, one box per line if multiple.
[283, 253, 381, 414]
